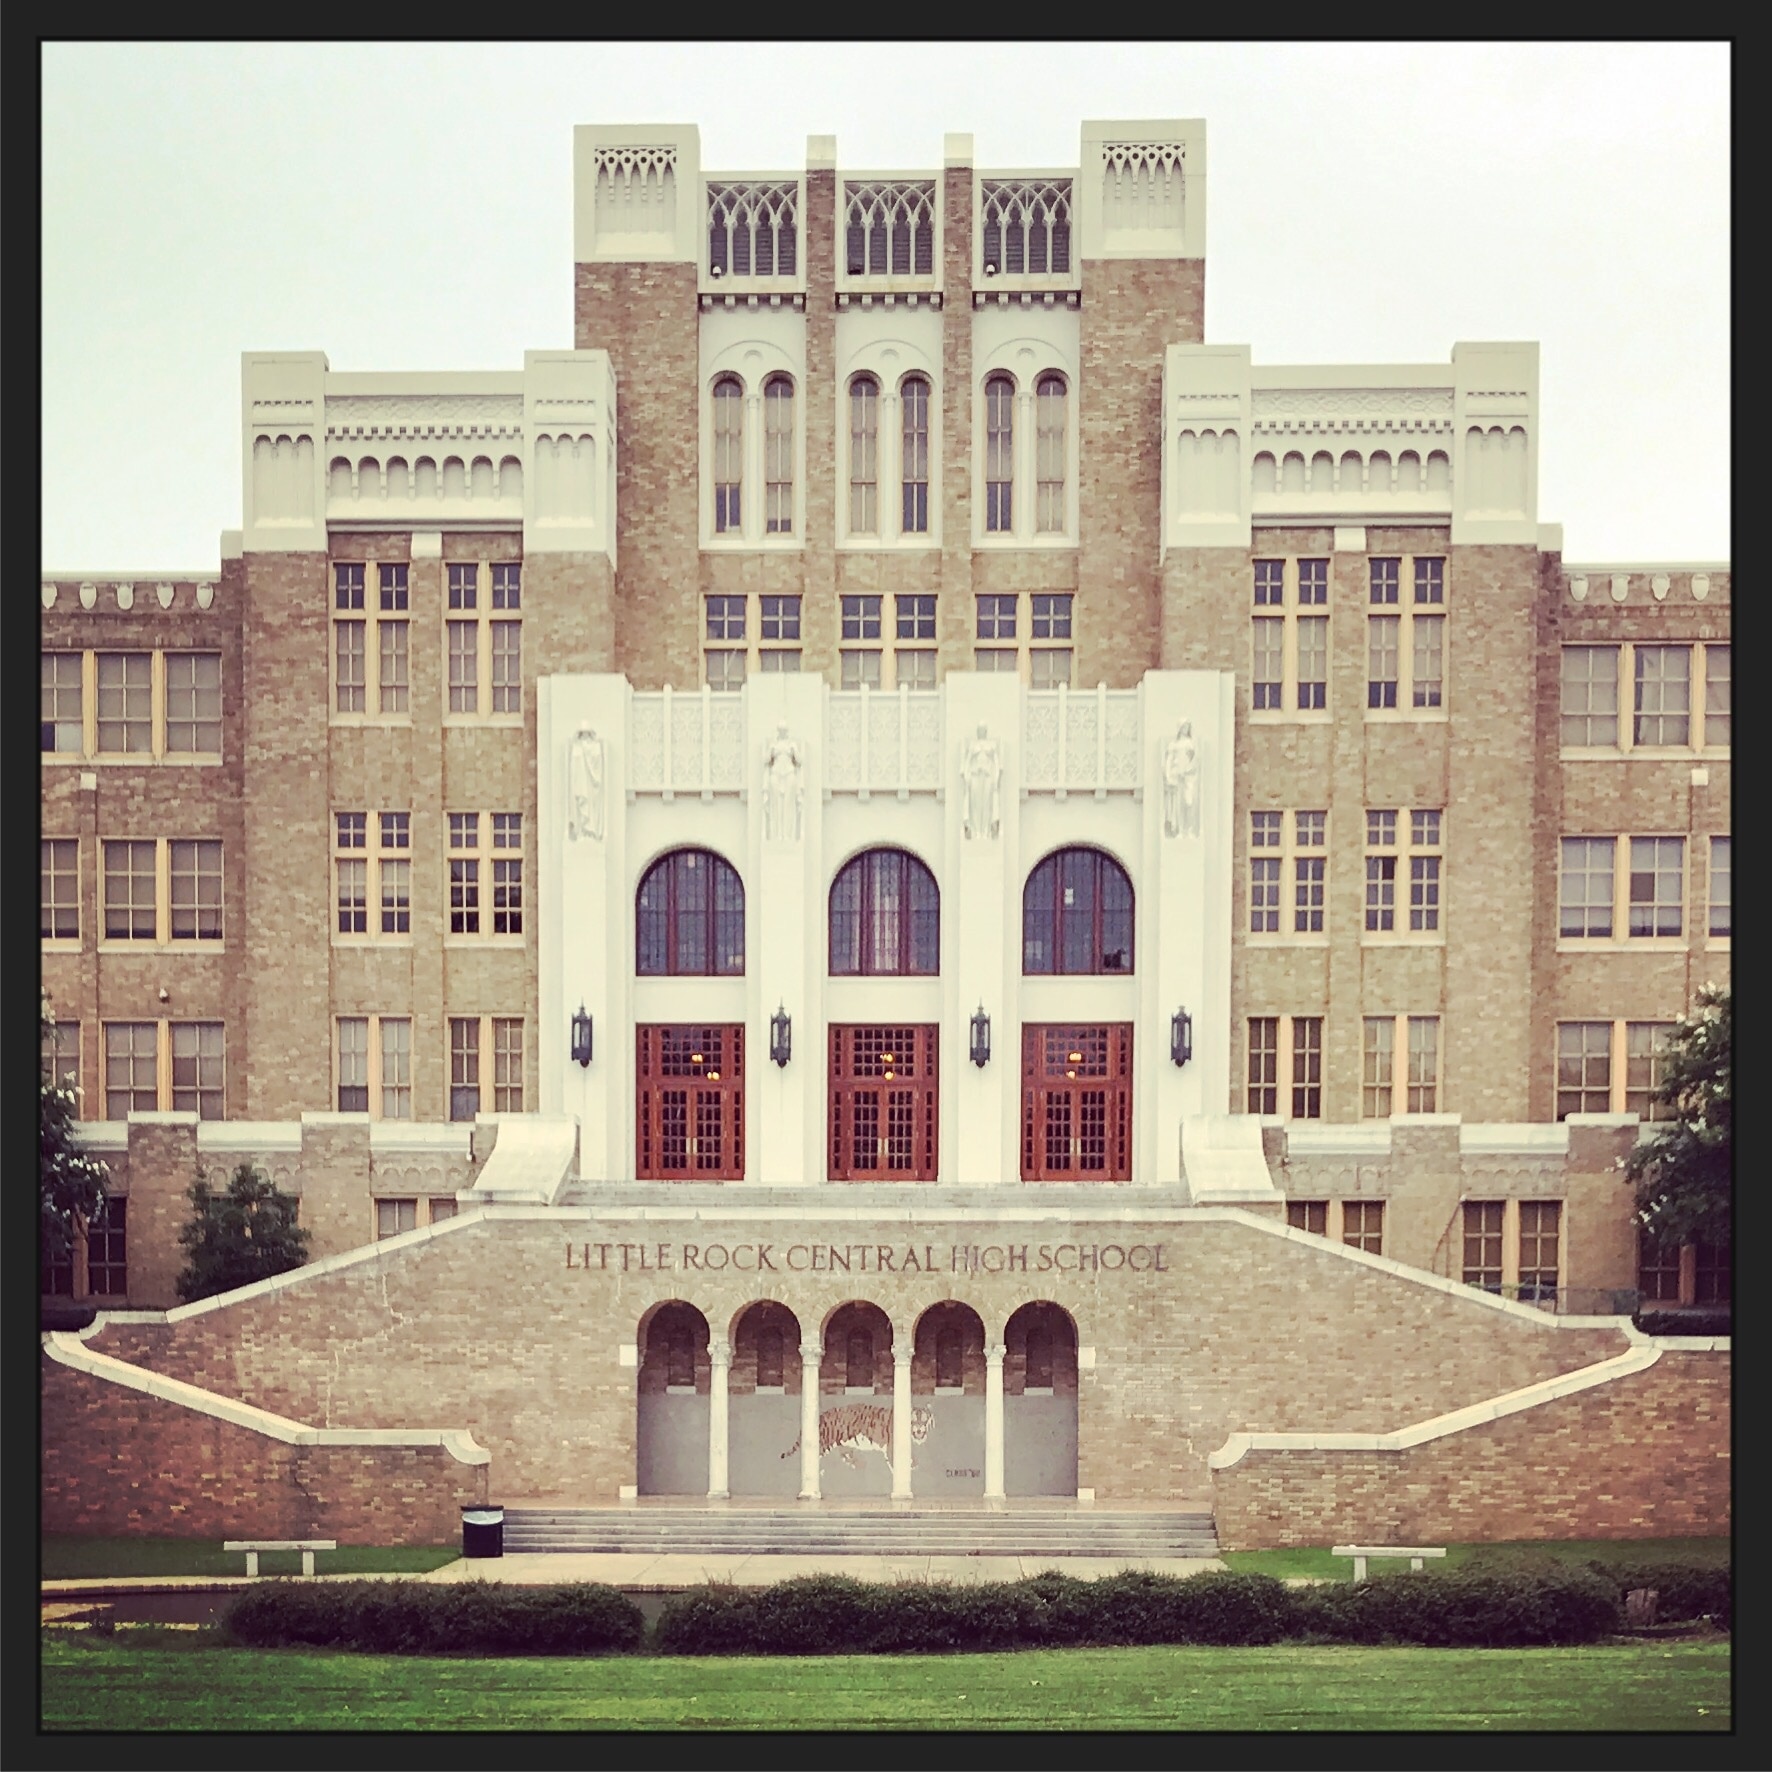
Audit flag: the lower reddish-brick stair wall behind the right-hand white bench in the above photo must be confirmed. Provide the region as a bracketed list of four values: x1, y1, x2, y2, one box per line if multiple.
[1212, 1352, 1731, 1551]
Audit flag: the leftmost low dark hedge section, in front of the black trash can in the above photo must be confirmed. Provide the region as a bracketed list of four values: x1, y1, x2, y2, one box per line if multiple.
[223, 1579, 647, 1655]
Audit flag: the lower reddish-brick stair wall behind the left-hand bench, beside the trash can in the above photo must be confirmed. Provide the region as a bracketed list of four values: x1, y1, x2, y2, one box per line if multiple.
[41, 1356, 487, 1545]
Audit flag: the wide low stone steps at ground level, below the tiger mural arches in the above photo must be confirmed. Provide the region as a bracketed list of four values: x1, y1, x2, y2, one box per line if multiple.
[505, 1506, 1219, 1561]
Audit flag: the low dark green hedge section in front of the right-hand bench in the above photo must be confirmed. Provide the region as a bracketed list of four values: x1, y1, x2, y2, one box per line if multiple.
[1295, 1561, 1620, 1648]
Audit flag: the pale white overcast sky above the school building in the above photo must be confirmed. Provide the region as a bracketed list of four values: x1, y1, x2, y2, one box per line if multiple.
[43, 43, 1729, 572]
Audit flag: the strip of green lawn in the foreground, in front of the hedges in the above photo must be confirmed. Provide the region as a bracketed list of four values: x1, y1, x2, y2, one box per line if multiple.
[43, 1630, 1729, 1731]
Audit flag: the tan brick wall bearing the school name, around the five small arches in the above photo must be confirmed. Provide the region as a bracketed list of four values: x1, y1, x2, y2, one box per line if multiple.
[79, 1217, 1625, 1506]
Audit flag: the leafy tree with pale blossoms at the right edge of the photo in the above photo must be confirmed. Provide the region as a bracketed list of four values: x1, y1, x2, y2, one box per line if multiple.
[1625, 985, 1735, 1247]
